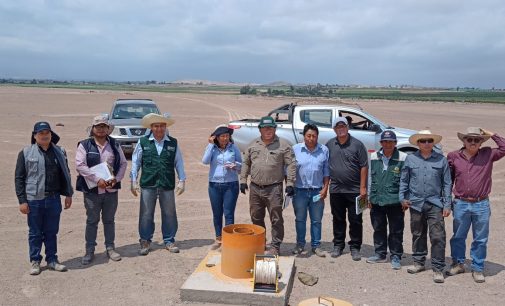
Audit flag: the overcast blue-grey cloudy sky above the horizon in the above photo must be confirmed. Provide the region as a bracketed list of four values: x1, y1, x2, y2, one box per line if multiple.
[0, 0, 505, 88]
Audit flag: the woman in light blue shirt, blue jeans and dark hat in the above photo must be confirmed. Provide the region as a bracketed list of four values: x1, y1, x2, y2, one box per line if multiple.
[202, 126, 242, 249]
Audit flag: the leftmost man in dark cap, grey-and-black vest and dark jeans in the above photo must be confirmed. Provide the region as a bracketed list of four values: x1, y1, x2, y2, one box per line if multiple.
[15, 122, 73, 275]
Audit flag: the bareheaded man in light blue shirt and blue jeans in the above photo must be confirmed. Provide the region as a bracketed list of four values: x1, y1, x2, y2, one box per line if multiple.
[293, 124, 330, 257]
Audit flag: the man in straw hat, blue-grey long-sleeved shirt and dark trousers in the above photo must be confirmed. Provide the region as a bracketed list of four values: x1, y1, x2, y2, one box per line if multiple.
[400, 130, 451, 283]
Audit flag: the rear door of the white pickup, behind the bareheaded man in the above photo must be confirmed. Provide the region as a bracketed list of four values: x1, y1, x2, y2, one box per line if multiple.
[293, 108, 335, 145]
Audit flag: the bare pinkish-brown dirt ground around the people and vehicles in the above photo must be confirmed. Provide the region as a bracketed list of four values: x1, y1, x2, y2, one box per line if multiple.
[0, 87, 505, 305]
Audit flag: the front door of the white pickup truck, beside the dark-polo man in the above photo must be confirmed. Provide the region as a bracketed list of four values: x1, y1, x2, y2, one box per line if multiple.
[339, 110, 380, 154]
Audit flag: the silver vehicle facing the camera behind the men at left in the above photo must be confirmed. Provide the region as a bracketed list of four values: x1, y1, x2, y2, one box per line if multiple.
[109, 99, 160, 154]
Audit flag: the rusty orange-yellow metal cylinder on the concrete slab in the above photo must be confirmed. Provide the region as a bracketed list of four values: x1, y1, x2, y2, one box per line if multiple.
[221, 224, 265, 278]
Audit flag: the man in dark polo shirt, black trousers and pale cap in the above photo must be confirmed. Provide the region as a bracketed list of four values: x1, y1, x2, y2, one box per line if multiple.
[326, 117, 368, 261]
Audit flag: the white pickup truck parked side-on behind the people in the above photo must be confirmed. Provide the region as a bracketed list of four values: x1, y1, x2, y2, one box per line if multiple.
[228, 104, 422, 154]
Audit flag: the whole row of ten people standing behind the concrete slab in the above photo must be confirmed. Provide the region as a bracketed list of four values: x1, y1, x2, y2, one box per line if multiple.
[15, 114, 505, 283]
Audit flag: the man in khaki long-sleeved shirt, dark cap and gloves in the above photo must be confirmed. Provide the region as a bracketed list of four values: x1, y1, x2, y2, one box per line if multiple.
[240, 116, 296, 255]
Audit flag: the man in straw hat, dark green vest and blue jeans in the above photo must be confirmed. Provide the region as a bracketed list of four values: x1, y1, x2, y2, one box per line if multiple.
[130, 113, 186, 255]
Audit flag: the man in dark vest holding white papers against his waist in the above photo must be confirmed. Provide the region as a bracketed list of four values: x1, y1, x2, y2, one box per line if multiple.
[75, 115, 128, 265]
